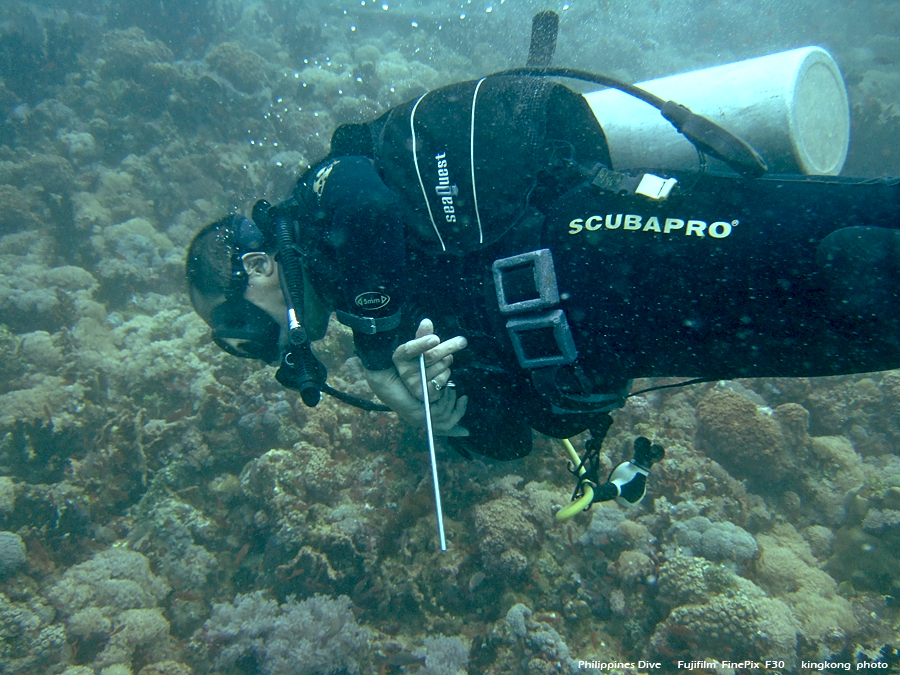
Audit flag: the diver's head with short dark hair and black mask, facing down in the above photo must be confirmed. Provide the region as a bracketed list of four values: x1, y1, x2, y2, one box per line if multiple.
[186, 215, 287, 363]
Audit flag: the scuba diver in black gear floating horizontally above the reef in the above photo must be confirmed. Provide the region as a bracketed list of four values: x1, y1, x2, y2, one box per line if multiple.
[187, 13, 900, 503]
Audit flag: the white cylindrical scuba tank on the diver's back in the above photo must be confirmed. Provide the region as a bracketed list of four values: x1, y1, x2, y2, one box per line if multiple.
[585, 47, 850, 175]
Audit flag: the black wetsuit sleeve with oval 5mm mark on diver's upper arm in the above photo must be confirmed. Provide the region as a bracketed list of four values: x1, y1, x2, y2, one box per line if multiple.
[300, 157, 406, 370]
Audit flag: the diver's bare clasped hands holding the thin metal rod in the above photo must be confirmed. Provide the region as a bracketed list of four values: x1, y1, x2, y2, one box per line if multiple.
[365, 319, 469, 436]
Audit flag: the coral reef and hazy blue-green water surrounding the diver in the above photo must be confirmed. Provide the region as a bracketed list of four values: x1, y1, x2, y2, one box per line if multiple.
[0, 0, 900, 675]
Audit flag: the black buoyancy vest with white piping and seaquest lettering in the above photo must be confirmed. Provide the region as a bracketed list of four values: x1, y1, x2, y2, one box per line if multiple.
[331, 76, 609, 255]
